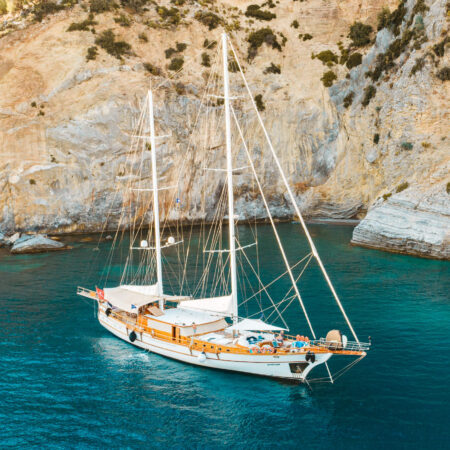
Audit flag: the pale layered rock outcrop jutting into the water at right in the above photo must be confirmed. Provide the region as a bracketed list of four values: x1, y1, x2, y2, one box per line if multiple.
[352, 185, 450, 259]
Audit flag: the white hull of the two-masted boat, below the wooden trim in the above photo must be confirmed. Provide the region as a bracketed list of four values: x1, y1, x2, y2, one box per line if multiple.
[98, 309, 332, 381]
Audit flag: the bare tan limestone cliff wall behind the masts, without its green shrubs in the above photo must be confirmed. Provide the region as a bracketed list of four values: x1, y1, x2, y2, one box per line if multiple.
[0, 0, 450, 258]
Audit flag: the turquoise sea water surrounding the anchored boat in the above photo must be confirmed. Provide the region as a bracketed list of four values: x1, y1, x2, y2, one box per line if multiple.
[0, 224, 450, 449]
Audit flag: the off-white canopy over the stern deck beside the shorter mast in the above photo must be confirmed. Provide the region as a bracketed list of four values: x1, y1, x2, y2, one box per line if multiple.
[103, 284, 186, 313]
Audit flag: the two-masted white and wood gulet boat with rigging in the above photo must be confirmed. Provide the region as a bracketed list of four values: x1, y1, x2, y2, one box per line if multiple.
[77, 33, 370, 382]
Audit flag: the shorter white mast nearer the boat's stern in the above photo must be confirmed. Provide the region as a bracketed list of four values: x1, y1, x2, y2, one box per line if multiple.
[148, 90, 164, 310]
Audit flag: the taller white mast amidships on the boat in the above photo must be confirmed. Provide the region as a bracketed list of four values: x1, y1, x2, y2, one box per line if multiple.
[222, 33, 238, 324]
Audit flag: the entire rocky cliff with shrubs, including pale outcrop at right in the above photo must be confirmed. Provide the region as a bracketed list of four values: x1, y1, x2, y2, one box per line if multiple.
[0, 0, 449, 257]
